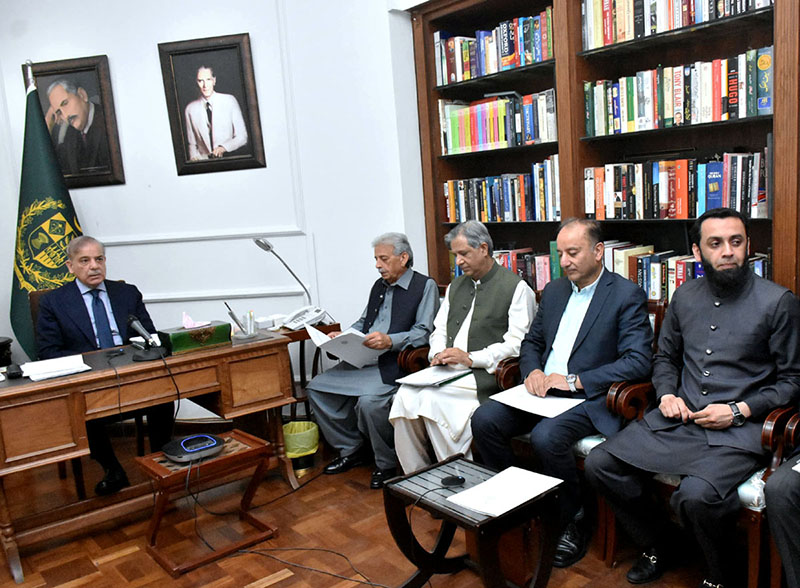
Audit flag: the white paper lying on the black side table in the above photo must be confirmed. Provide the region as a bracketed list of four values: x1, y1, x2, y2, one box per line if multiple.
[447, 467, 562, 517]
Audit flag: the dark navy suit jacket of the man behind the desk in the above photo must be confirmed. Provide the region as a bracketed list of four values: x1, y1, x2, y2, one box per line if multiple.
[36, 280, 156, 359]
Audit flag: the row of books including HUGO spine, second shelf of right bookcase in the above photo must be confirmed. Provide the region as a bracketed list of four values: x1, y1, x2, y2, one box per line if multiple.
[583, 46, 773, 137]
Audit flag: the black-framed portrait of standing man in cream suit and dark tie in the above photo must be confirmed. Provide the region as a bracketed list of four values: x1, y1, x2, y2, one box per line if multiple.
[158, 33, 267, 176]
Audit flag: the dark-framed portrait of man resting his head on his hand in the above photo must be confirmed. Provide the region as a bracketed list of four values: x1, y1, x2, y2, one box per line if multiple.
[22, 55, 125, 188]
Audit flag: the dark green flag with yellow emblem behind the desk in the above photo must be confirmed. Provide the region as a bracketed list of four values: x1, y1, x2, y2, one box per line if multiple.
[11, 86, 81, 358]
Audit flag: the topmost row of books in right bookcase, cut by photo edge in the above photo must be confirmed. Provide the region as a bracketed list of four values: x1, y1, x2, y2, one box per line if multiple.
[581, 0, 774, 51]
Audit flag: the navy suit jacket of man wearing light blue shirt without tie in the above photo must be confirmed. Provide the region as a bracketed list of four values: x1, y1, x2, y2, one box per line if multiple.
[520, 270, 653, 435]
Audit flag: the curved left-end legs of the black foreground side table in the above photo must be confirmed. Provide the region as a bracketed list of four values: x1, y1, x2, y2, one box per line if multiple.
[383, 487, 466, 588]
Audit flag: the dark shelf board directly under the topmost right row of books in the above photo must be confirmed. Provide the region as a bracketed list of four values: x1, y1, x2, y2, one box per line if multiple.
[578, 6, 774, 59]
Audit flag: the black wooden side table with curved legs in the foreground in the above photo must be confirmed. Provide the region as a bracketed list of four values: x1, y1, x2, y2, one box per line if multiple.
[383, 455, 558, 588]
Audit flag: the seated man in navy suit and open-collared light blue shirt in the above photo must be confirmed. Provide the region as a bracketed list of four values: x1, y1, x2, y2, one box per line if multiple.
[472, 219, 653, 567]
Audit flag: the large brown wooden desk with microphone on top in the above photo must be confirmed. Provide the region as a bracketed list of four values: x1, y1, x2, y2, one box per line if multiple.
[0, 333, 297, 582]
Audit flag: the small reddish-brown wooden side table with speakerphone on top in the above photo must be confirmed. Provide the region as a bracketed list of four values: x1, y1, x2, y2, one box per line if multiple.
[136, 429, 278, 578]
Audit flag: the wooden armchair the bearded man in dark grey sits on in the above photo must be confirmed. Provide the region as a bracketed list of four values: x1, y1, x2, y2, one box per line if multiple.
[605, 382, 800, 588]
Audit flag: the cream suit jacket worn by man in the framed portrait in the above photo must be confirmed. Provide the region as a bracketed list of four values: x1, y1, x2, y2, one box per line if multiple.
[185, 92, 247, 161]
